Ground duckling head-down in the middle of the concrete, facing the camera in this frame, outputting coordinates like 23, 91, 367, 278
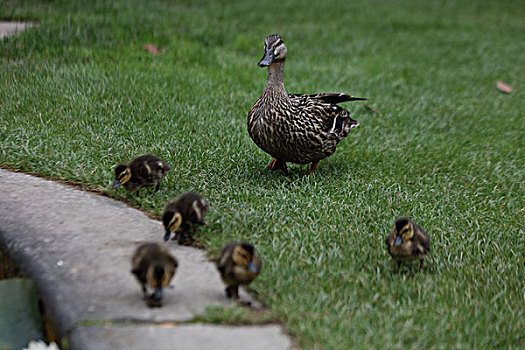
131, 243, 179, 307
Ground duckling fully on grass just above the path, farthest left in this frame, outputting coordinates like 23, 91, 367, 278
113, 154, 171, 194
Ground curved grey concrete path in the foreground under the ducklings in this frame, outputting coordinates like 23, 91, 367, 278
0, 169, 292, 350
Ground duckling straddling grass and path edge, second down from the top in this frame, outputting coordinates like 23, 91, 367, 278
162, 192, 210, 245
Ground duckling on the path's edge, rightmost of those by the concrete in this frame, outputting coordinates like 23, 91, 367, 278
215, 242, 262, 299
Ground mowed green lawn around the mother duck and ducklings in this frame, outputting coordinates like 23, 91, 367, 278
0, 0, 525, 349
